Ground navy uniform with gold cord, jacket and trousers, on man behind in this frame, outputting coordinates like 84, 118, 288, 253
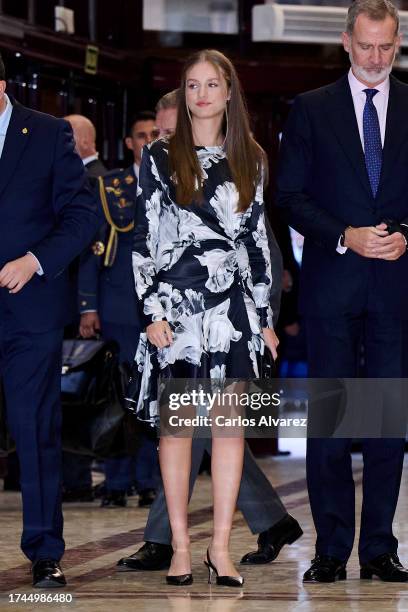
78, 166, 158, 506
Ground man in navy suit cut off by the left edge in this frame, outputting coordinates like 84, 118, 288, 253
0, 59, 98, 587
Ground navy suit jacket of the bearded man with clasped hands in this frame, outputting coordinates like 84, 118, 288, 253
278, 76, 408, 318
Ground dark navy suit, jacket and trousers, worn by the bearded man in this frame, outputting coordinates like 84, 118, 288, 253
278, 77, 408, 563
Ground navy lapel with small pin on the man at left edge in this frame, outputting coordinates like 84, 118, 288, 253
0, 99, 31, 196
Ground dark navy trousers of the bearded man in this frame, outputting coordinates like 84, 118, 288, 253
306, 313, 408, 563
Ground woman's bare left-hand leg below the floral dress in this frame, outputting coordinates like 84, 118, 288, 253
159, 436, 191, 576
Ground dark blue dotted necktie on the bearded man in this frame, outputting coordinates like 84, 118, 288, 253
363, 89, 382, 197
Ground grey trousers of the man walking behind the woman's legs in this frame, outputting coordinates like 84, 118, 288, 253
143, 438, 287, 544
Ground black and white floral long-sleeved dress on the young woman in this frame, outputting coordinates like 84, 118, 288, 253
132, 139, 273, 422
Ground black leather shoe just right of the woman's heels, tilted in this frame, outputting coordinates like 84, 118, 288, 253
241, 514, 303, 565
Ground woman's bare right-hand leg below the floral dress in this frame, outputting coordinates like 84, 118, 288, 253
209, 438, 245, 576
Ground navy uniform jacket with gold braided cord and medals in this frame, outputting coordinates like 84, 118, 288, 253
78, 165, 141, 327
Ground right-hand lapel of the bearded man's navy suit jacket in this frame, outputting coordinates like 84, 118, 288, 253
378, 76, 408, 193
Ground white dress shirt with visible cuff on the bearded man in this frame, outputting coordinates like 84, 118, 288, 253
336, 68, 390, 255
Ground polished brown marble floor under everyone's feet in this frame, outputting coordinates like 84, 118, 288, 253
0, 452, 408, 612
